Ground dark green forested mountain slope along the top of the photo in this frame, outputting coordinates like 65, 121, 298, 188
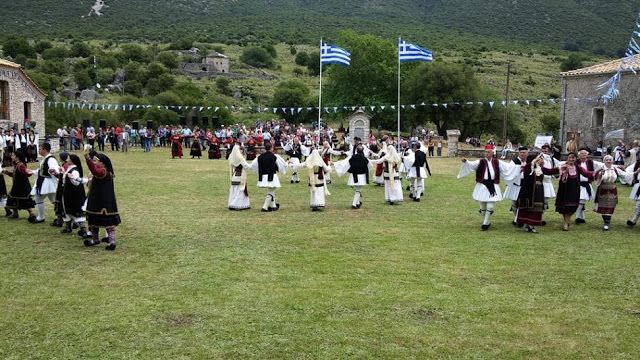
0, 0, 640, 56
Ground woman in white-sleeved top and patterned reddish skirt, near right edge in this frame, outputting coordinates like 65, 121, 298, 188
593, 155, 626, 231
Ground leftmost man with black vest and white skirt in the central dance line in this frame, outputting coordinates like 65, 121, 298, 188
251, 142, 287, 212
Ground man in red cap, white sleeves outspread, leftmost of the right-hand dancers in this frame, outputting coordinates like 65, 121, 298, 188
458, 145, 521, 230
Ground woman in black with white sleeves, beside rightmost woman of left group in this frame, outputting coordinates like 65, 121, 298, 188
60, 154, 88, 237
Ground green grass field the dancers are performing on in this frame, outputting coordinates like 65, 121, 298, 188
0, 148, 640, 359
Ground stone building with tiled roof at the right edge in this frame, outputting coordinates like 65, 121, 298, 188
560, 55, 640, 149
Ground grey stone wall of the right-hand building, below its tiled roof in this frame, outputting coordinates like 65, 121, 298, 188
561, 73, 640, 149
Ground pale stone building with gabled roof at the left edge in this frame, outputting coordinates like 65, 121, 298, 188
0, 59, 46, 138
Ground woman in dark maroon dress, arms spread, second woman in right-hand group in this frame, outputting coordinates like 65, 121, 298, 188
542, 152, 594, 231
